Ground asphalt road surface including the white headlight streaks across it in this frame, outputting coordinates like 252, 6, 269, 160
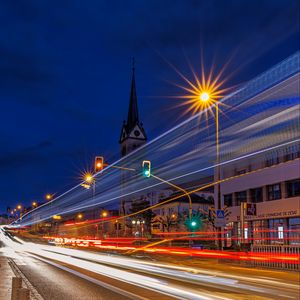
0, 229, 299, 300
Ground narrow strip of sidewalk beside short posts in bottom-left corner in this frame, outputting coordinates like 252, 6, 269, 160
0, 252, 14, 300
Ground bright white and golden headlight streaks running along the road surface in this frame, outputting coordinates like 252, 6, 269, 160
0, 230, 298, 299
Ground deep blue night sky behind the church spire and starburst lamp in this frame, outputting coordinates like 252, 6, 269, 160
0, 0, 300, 213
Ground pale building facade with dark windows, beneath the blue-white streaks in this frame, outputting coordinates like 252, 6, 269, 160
221, 144, 300, 246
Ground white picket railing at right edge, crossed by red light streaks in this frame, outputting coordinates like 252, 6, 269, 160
251, 245, 300, 270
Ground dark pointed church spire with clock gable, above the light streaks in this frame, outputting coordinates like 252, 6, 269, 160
119, 60, 147, 157
